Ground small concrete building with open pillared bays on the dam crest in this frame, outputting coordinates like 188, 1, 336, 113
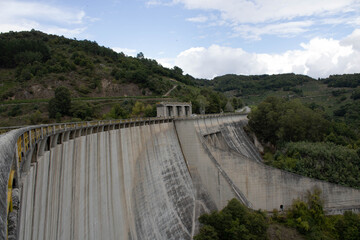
156, 102, 192, 117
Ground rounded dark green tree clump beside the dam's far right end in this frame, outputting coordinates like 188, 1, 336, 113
249, 97, 330, 145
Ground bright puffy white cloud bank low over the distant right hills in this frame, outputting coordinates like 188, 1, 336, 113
174, 29, 360, 79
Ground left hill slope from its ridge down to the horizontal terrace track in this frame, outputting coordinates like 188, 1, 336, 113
0, 31, 195, 100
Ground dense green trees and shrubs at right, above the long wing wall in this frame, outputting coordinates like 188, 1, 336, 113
249, 97, 360, 188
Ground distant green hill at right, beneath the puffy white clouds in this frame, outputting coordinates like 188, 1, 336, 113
205, 74, 360, 126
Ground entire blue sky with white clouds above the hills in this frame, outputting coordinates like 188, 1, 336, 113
0, 0, 360, 79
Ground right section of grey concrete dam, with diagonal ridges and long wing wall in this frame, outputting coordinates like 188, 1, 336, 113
175, 116, 360, 214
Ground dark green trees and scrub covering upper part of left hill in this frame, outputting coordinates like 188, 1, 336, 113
0, 30, 193, 99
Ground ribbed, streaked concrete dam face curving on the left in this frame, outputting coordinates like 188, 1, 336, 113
19, 123, 195, 239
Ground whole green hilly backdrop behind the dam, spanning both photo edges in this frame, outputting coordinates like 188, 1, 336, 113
0, 30, 360, 129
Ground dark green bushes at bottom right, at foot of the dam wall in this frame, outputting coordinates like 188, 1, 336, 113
194, 189, 360, 240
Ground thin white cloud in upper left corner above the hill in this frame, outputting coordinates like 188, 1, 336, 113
0, 0, 89, 37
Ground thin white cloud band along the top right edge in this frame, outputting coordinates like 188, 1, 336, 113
173, 0, 359, 23
